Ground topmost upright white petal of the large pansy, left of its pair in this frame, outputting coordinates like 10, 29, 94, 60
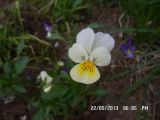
76, 28, 94, 54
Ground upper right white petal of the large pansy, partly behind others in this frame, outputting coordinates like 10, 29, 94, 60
92, 32, 115, 52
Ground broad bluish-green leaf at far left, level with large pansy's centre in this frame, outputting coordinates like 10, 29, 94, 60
15, 56, 29, 74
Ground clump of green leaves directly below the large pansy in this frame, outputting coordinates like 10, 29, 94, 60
31, 66, 106, 120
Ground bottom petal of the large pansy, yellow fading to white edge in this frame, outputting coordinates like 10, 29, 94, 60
70, 63, 100, 84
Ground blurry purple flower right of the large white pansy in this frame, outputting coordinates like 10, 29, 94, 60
120, 38, 135, 59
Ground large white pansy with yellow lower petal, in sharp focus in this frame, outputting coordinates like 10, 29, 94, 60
68, 28, 115, 84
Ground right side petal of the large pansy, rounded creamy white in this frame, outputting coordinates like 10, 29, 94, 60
90, 47, 111, 66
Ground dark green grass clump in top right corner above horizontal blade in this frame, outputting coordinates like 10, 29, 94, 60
120, 0, 160, 27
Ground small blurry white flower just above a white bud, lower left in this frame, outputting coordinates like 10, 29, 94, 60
37, 71, 53, 83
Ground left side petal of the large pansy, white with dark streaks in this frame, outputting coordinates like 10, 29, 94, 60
68, 43, 88, 63
